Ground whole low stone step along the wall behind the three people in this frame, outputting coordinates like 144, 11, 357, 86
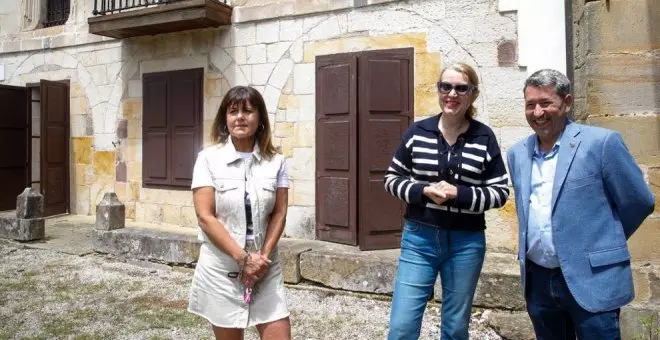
94, 226, 524, 310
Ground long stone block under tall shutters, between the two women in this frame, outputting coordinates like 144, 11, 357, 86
300, 241, 399, 294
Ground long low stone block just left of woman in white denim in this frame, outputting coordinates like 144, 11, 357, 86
94, 228, 201, 265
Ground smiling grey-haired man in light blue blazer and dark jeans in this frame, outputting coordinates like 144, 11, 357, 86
508, 69, 655, 340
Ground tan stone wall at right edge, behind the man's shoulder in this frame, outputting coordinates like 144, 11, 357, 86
573, 0, 660, 261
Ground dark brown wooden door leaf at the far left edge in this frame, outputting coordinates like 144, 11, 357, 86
0, 85, 30, 211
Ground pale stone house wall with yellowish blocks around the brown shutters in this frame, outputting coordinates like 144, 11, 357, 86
0, 0, 531, 252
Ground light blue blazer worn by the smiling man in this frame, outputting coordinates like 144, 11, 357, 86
508, 121, 655, 312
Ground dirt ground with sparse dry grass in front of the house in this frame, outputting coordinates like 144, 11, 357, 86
0, 240, 500, 340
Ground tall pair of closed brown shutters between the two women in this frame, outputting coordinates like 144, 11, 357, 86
316, 48, 414, 250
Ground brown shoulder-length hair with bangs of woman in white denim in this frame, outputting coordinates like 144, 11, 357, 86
211, 86, 277, 159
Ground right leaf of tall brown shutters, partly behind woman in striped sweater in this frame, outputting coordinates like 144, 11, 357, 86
358, 48, 414, 250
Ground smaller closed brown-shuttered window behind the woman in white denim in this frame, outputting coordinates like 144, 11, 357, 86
142, 69, 204, 189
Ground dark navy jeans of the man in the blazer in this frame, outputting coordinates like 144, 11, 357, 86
525, 261, 621, 340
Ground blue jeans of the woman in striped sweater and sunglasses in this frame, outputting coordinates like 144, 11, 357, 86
387, 221, 486, 340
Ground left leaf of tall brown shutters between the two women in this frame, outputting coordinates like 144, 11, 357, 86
316, 54, 358, 245
